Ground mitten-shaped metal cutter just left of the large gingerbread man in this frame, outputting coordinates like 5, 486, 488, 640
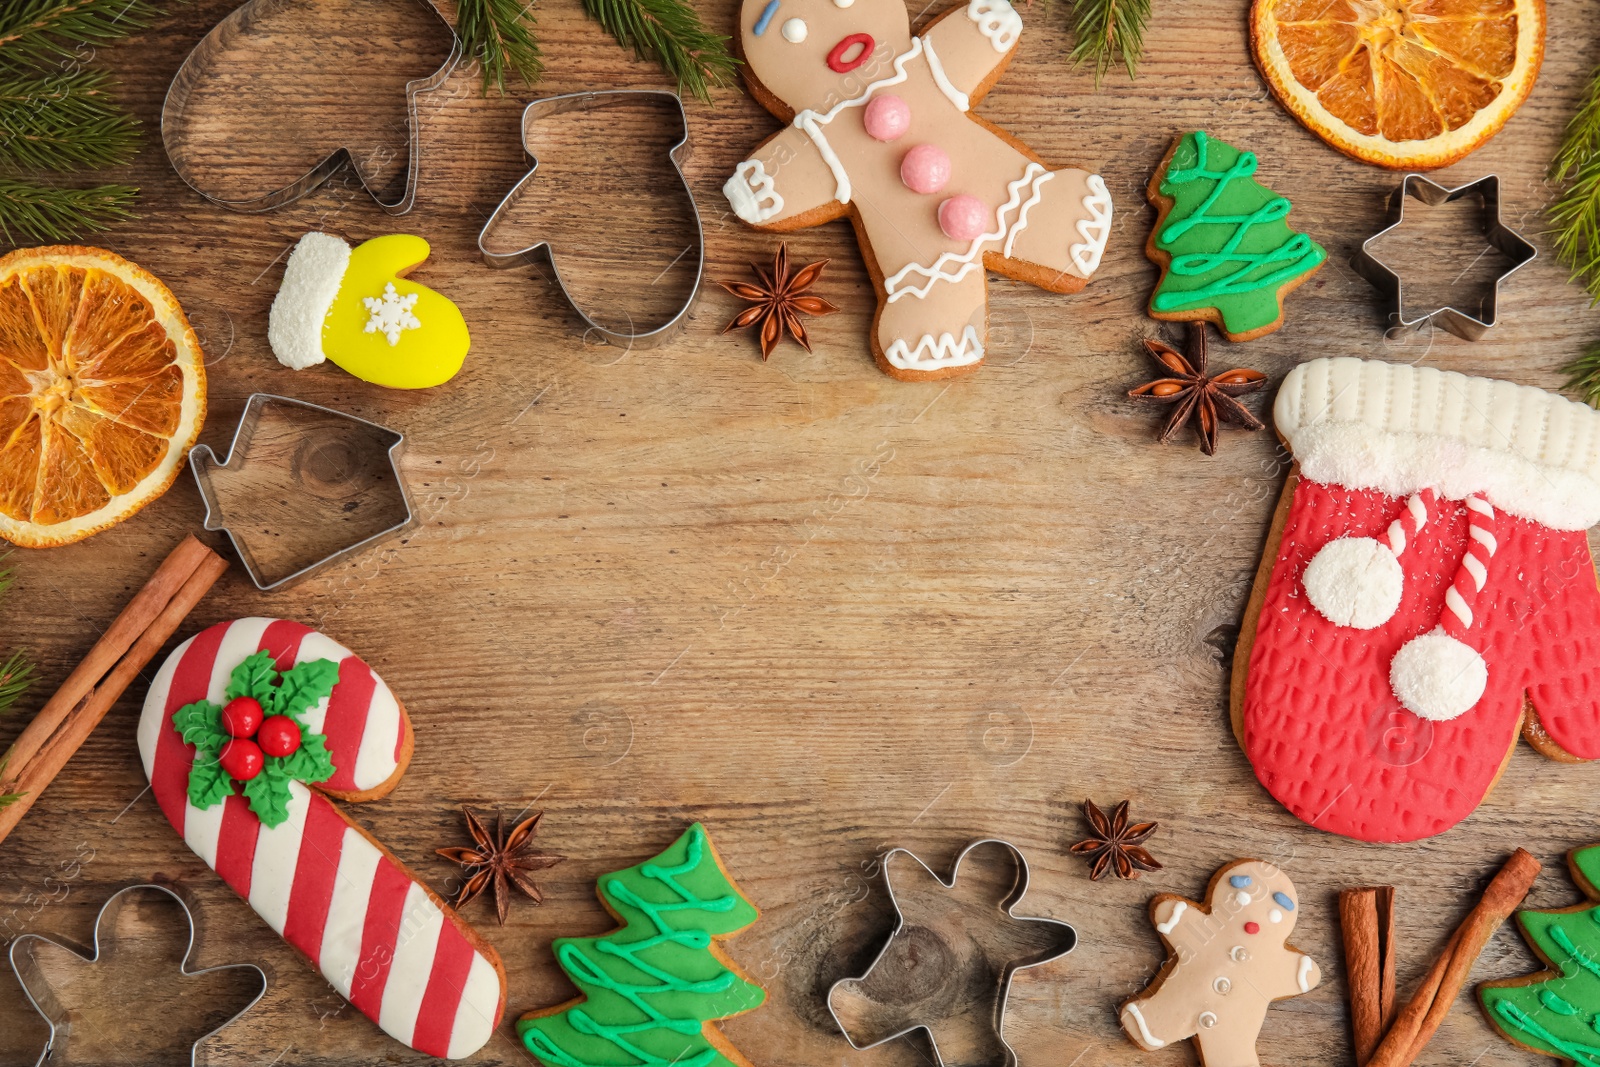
478, 90, 706, 349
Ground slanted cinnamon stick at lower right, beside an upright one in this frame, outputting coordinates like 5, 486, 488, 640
1368, 848, 1539, 1067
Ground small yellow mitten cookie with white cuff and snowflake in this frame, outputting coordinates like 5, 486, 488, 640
267, 232, 472, 389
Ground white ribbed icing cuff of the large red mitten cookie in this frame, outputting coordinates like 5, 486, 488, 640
1272, 357, 1600, 530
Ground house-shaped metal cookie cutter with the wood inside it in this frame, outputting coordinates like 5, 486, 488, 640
189, 394, 414, 592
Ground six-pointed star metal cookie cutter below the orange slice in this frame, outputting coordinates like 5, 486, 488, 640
1350, 174, 1539, 341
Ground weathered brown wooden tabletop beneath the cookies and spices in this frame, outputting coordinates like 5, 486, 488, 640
0, 0, 1600, 1067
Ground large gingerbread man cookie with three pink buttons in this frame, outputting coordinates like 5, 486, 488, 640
723, 0, 1110, 381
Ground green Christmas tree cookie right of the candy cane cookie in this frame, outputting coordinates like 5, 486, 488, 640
517, 822, 766, 1067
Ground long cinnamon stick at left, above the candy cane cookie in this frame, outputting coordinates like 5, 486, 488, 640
0, 536, 227, 841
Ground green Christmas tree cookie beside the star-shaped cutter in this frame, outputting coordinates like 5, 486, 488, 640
1146, 130, 1328, 341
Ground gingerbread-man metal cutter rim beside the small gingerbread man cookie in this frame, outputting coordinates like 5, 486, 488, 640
827, 837, 1078, 1067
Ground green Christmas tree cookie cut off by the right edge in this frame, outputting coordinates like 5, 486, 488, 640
1478, 845, 1600, 1067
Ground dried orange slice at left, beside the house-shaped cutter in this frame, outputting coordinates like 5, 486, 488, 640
0, 246, 205, 549
